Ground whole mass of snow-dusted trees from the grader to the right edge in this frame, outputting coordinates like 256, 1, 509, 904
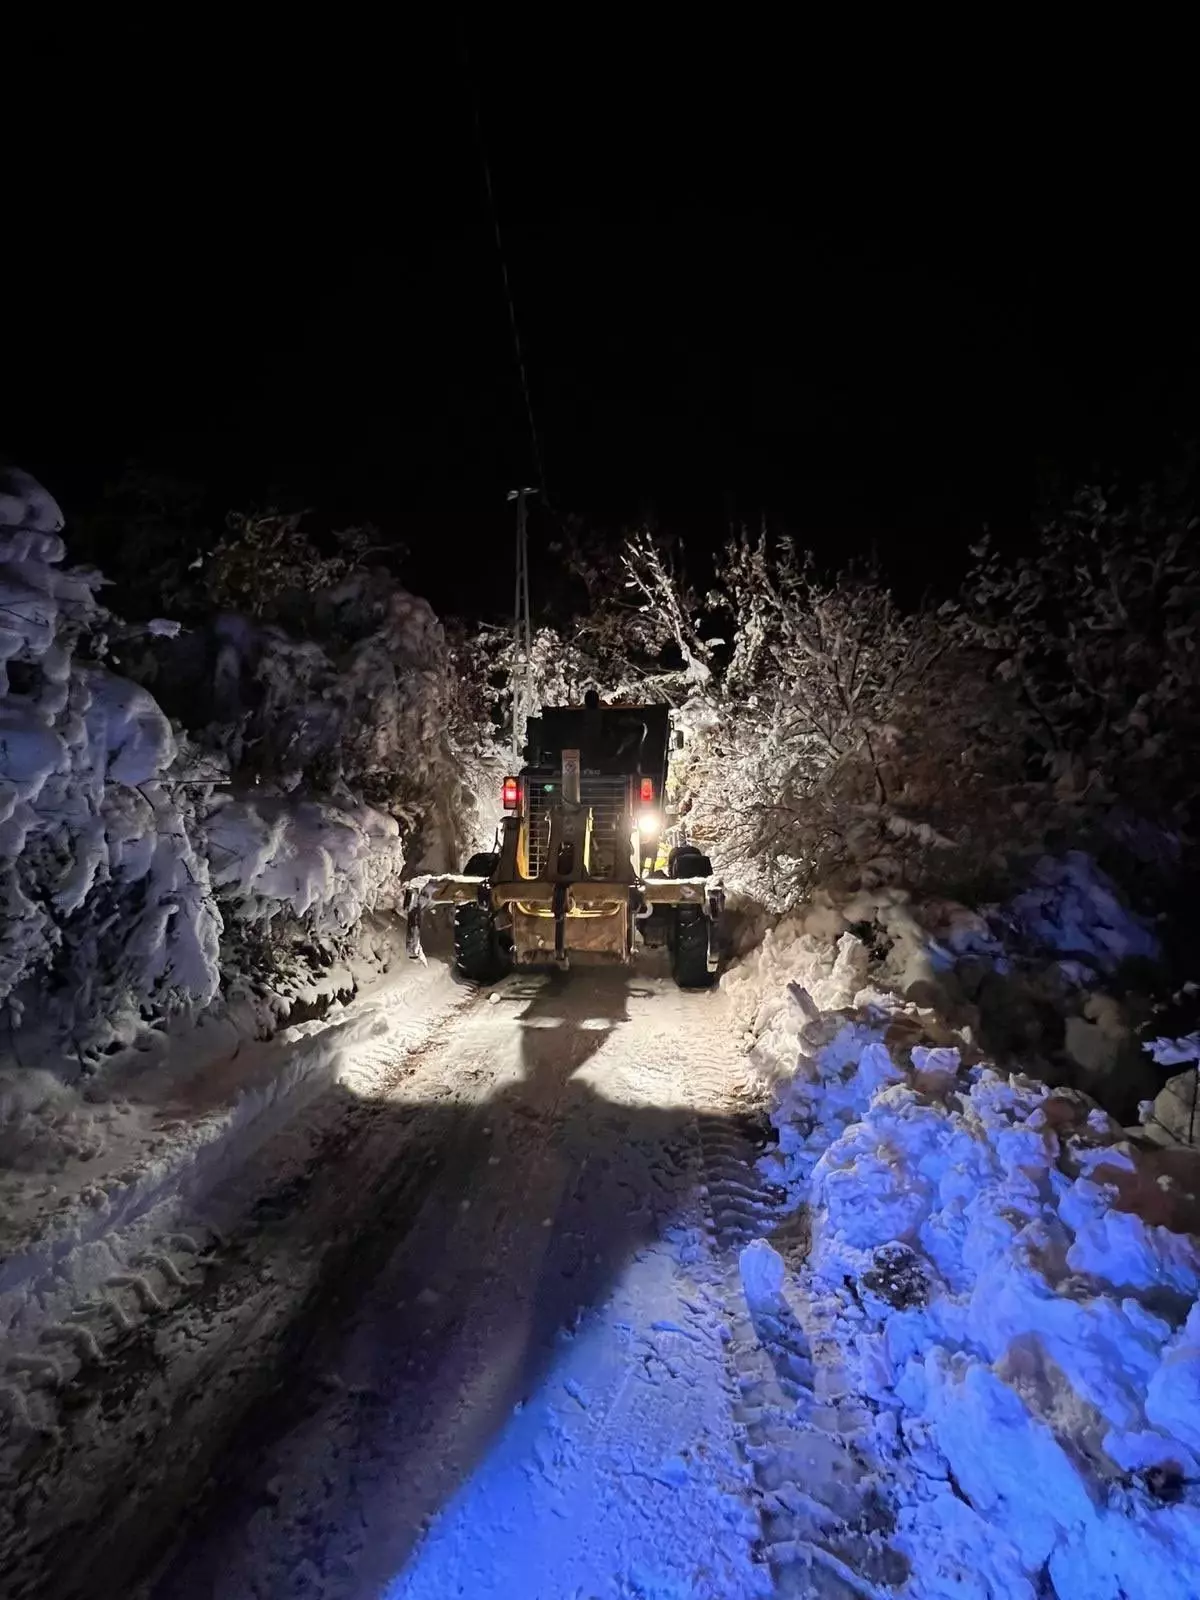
626, 491, 1200, 907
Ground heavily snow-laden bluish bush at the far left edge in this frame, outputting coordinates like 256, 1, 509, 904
0, 472, 221, 1048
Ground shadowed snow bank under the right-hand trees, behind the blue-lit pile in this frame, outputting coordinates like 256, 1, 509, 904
725, 853, 1181, 1130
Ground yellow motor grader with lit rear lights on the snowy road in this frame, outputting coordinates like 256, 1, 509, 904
405, 694, 725, 989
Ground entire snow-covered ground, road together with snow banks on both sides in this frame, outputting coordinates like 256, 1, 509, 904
0, 902, 1200, 1600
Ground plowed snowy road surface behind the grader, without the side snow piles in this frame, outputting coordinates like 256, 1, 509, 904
5, 971, 813, 1600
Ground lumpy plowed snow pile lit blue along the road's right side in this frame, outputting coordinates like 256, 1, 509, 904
726, 896, 1200, 1600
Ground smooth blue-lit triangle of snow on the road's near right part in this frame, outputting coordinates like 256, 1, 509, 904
395, 1229, 771, 1600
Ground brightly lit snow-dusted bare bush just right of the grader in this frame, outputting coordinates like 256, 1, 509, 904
582, 534, 1029, 910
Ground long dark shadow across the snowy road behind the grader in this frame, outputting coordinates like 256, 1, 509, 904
37, 973, 752, 1600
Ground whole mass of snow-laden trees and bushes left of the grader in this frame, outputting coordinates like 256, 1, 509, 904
0, 474, 498, 1062
